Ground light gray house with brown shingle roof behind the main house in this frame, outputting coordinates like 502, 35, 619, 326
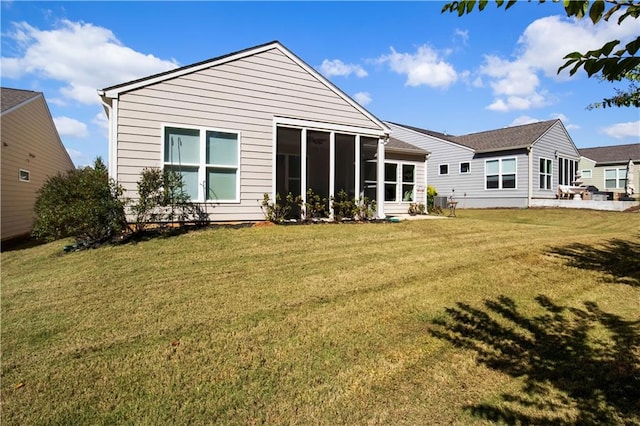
386, 120, 580, 208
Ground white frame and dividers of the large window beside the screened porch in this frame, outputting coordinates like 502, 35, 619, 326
160, 123, 242, 204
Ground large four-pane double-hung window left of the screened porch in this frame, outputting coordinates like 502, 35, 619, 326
164, 127, 240, 202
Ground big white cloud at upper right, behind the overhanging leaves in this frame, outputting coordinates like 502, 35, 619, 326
479, 16, 637, 111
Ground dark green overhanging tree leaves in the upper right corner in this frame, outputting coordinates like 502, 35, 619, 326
442, 0, 640, 86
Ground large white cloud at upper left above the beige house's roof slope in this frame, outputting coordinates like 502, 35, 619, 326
1, 20, 177, 104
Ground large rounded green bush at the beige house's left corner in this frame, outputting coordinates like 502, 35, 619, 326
32, 157, 126, 246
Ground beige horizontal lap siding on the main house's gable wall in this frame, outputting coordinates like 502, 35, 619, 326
117, 49, 379, 220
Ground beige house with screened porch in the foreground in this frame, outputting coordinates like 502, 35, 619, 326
98, 41, 427, 221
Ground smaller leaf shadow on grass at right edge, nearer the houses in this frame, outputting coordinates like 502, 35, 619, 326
551, 239, 640, 286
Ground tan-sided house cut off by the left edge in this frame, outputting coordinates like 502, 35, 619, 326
0, 87, 74, 243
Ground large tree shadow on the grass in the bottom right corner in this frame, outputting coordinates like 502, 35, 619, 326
431, 296, 640, 425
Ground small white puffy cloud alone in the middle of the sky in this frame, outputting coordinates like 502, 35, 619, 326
377, 45, 458, 88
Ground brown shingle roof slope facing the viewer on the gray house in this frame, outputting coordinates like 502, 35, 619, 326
456, 120, 559, 152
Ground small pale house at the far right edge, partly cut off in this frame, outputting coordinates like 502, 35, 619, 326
578, 143, 640, 198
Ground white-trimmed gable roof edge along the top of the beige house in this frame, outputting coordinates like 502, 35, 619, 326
98, 40, 390, 133
